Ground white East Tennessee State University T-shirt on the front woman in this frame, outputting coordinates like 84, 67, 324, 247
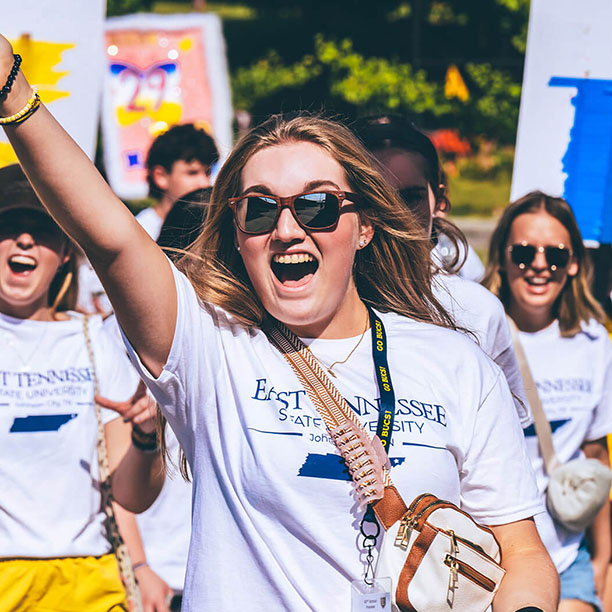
123, 270, 542, 612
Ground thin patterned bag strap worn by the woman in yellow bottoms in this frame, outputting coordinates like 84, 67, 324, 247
83, 316, 143, 612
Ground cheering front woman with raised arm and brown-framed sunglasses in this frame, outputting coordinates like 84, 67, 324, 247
0, 39, 557, 612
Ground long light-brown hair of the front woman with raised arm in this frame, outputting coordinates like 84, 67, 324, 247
179, 114, 455, 328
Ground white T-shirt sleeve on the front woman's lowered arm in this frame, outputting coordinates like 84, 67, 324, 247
460, 369, 544, 525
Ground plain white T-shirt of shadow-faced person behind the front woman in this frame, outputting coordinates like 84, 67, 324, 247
432, 272, 533, 427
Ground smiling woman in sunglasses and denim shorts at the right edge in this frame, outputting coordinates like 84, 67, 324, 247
484, 192, 612, 612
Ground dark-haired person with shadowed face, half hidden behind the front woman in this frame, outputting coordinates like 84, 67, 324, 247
354, 115, 531, 427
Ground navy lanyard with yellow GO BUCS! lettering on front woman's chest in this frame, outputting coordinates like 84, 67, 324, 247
368, 306, 395, 455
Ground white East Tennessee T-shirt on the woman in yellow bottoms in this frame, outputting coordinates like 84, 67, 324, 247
0, 313, 138, 558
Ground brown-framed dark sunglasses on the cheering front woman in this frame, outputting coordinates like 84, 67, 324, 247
229, 191, 360, 235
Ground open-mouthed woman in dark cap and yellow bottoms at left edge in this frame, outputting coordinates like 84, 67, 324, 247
0, 165, 164, 612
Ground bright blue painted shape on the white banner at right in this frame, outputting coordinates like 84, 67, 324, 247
548, 76, 612, 244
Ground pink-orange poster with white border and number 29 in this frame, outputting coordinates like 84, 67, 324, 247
102, 13, 233, 198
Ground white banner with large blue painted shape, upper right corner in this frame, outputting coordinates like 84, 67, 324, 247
511, 0, 612, 243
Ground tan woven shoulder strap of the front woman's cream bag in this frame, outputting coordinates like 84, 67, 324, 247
264, 322, 408, 529
